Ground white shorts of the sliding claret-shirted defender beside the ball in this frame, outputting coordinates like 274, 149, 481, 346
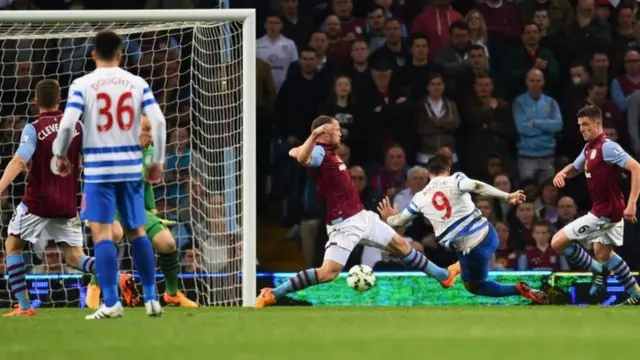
324, 210, 396, 265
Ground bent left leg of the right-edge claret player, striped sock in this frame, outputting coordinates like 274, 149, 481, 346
551, 228, 609, 296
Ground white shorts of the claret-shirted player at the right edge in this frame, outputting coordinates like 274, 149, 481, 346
564, 213, 624, 246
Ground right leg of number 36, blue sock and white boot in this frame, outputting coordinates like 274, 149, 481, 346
127, 226, 163, 317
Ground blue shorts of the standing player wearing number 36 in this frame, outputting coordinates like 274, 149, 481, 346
80, 180, 146, 231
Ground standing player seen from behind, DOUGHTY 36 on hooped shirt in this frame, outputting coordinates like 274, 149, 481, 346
53, 31, 166, 320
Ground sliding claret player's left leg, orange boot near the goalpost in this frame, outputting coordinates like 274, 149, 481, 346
255, 258, 344, 308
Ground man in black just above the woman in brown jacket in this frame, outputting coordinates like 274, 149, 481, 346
394, 34, 442, 100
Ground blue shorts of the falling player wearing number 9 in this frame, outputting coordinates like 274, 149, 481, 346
458, 224, 499, 284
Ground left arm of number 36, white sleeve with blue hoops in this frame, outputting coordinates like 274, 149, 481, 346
53, 83, 84, 157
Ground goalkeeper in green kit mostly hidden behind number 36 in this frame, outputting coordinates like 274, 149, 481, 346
86, 116, 198, 309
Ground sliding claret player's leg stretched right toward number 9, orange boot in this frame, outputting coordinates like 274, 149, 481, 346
385, 234, 460, 289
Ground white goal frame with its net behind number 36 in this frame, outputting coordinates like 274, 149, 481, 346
0, 9, 257, 307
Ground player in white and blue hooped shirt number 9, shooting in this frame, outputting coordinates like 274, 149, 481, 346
380, 155, 546, 303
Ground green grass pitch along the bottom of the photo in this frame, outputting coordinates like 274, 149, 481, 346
0, 307, 640, 360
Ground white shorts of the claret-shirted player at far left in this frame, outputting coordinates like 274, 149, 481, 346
9, 204, 84, 248
